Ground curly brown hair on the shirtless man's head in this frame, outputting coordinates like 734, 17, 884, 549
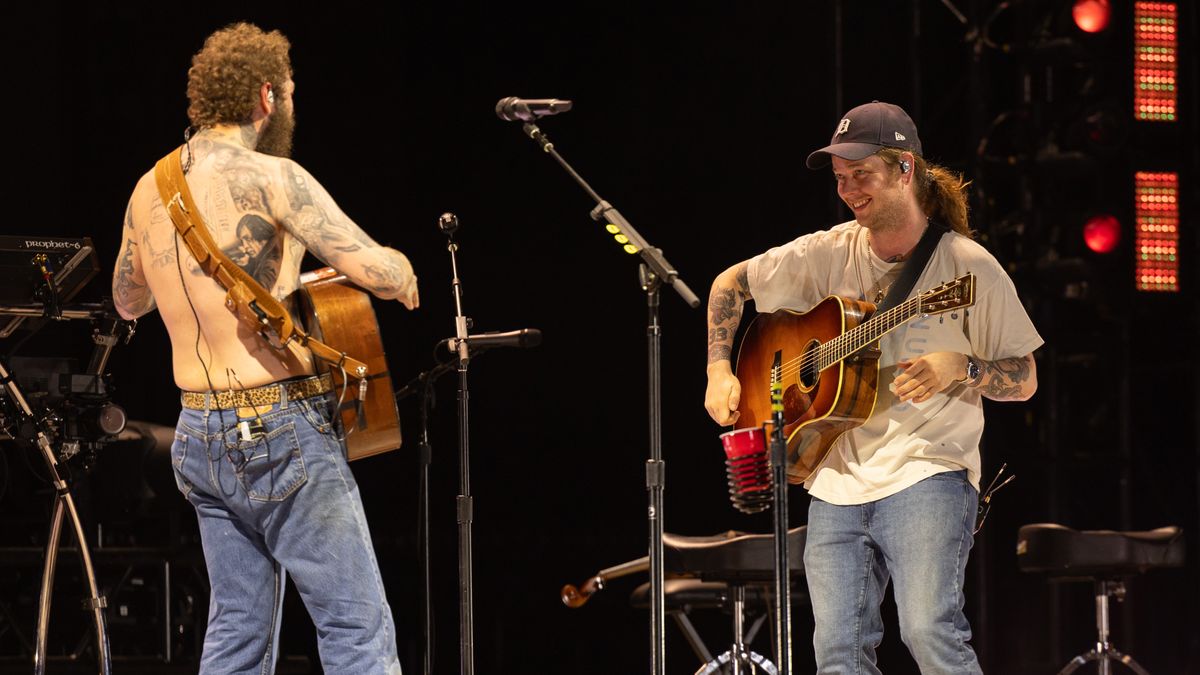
187, 23, 292, 129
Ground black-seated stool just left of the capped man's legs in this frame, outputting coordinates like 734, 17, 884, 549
630, 526, 808, 675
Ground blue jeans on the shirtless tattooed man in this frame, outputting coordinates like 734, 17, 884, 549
170, 389, 400, 675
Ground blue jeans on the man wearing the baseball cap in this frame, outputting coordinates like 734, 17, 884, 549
804, 471, 982, 675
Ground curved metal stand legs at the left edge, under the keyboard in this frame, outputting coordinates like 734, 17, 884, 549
0, 362, 112, 675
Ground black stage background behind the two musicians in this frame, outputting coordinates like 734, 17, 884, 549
0, 0, 1200, 674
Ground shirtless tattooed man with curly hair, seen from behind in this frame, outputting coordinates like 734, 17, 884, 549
113, 23, 419, 675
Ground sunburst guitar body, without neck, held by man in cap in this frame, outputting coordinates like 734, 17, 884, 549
734, 297, 880, 483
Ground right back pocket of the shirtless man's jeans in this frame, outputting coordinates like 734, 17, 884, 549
234, 422, 308, 502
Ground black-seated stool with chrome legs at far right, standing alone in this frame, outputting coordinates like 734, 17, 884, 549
1016, 522, 1184, 675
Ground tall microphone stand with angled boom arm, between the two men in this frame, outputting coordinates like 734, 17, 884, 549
521, 121, 700, 675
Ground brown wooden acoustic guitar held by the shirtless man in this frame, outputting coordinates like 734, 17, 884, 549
295, 267, 401, 461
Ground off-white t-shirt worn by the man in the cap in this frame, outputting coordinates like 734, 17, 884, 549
748, 221, 1043, 504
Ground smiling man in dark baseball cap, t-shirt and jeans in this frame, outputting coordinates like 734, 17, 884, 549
704, 101, 1043, 674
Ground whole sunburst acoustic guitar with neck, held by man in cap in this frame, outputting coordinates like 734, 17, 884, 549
734, 274, 974, 483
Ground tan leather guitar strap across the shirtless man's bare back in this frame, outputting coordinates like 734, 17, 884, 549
154, 145, 367, 380
